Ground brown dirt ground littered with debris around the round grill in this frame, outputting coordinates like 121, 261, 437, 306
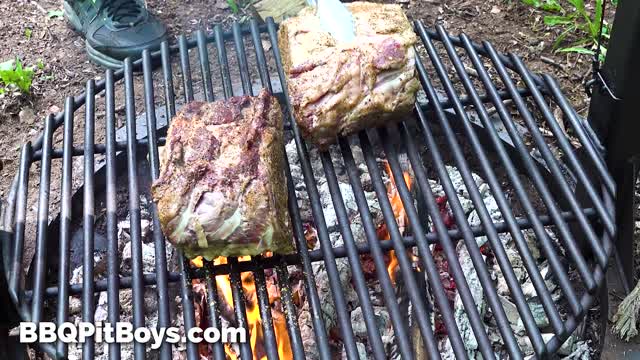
0, 0, 624, 356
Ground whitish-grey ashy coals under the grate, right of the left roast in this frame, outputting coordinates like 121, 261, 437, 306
286, 135, 580, 359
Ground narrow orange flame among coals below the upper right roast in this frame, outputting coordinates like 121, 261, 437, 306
378, 162, 411, 283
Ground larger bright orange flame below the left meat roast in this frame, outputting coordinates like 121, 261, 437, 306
191, 253, 293, 360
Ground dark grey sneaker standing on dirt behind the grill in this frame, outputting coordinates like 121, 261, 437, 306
64, 0, 167, 69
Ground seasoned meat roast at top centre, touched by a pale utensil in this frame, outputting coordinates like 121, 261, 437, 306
279, 2, 419, 148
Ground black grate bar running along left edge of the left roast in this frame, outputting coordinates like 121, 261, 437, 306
142, 50, 172, 360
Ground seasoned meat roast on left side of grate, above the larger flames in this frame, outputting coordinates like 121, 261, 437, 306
152, 91, 293, 259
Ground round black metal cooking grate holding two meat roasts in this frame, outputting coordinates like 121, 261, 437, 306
4, 19, 615, 359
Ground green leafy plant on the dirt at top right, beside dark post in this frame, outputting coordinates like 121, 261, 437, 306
522, 0, 617, 60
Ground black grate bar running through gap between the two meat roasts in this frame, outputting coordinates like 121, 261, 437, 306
266, 18, 342, 360
